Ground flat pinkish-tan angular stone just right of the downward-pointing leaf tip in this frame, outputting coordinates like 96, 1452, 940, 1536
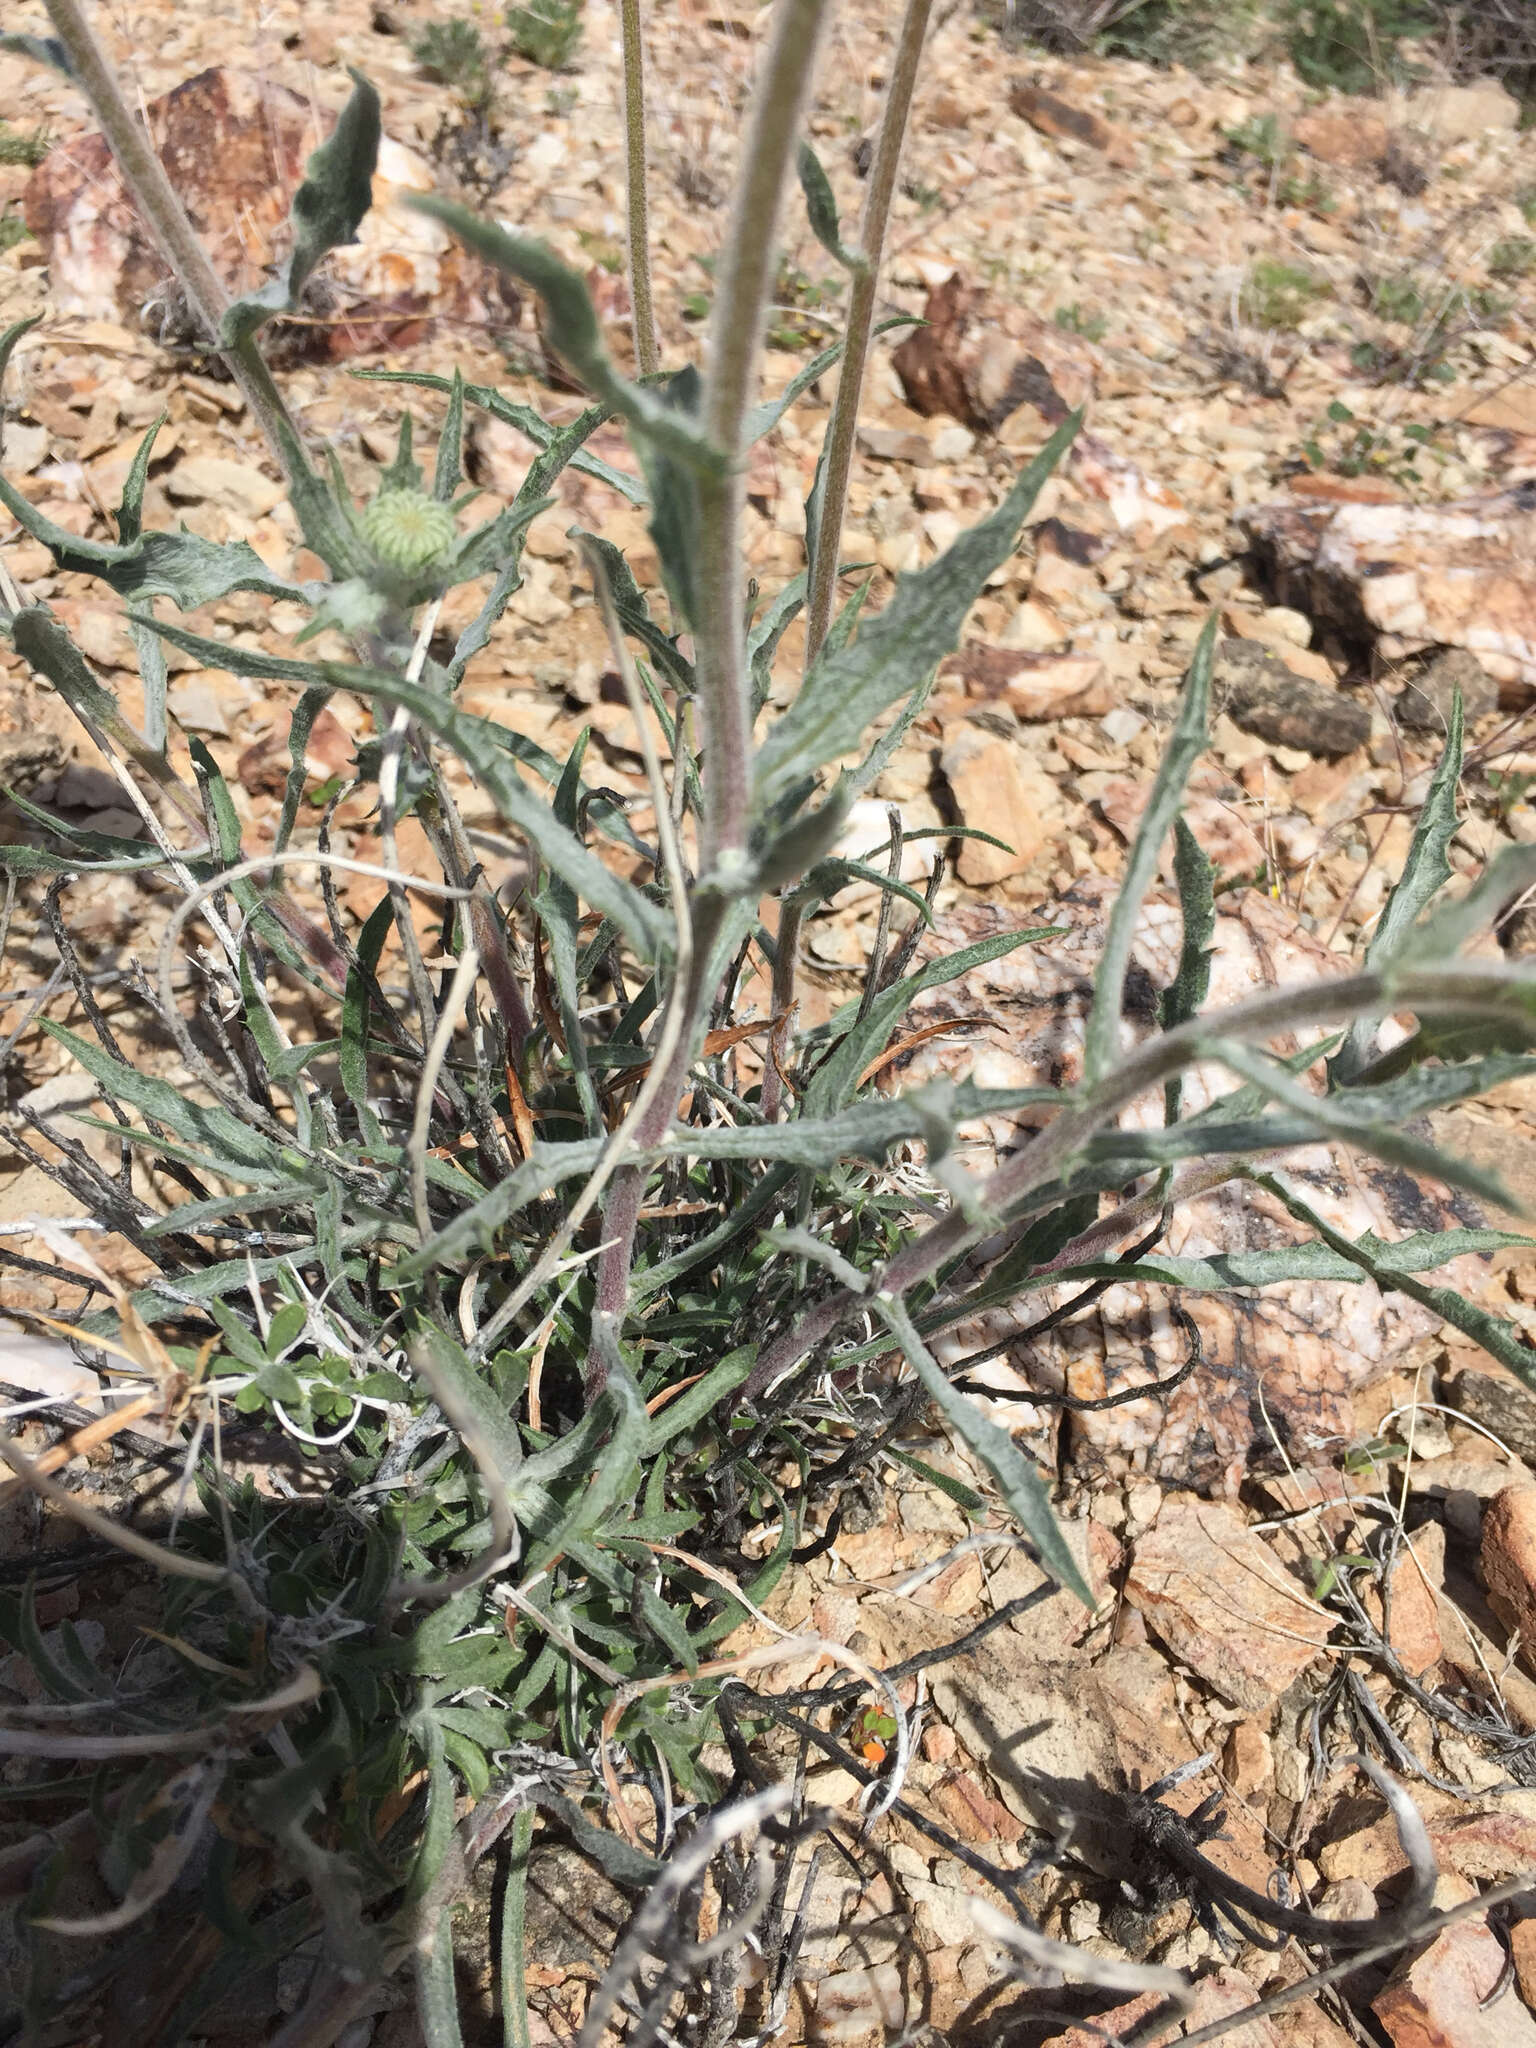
1124, 1503, 1329, 1714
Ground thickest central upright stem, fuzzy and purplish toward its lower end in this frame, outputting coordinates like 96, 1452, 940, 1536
692, 0, 825, 874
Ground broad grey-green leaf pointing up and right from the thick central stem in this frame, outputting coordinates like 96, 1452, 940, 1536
758, 414, 1081, 805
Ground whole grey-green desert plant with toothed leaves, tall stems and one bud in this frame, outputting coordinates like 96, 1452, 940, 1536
0, 0, 1536, 2048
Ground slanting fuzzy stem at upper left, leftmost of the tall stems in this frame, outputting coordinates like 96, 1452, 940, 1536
45, 0, 313, 477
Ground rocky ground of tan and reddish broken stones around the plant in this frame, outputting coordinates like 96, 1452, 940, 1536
0, 0, 1536, 2048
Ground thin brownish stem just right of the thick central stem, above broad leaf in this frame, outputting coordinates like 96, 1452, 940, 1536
805, 0, 932, 670
